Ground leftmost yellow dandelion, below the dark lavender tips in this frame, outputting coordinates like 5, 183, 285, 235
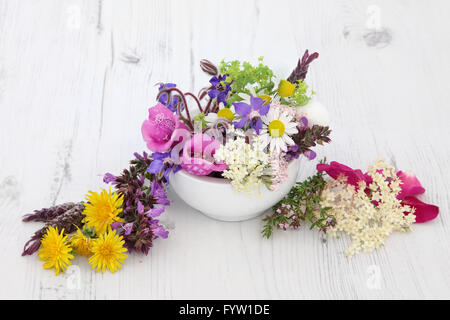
38, 226, 73, 275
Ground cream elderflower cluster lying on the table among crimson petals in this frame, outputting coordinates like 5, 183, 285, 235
322, 160, 416, 256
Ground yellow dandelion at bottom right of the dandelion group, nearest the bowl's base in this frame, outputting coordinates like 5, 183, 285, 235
89, 228, 128, 273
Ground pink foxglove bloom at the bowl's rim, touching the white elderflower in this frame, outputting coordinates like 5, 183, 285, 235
181, 133, 227, 176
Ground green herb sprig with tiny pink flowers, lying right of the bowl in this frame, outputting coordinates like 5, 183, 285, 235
262, 172, 336, 238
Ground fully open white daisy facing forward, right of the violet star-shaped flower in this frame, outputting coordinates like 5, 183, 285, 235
261, 108, 298, 153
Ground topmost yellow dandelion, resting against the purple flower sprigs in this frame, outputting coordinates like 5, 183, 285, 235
83, 188, 123, 234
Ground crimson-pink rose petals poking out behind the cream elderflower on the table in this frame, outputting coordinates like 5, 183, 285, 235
317, 161, 439, 223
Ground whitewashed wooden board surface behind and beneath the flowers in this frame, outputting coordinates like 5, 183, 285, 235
0, 0, 450, 299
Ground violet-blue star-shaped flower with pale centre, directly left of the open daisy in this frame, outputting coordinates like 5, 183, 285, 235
233, 95, 270, 134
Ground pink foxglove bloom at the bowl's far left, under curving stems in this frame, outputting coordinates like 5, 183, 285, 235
141, 103, 189, 152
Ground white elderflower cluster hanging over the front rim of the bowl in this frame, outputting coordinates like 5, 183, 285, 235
214, 126, 270, 194
